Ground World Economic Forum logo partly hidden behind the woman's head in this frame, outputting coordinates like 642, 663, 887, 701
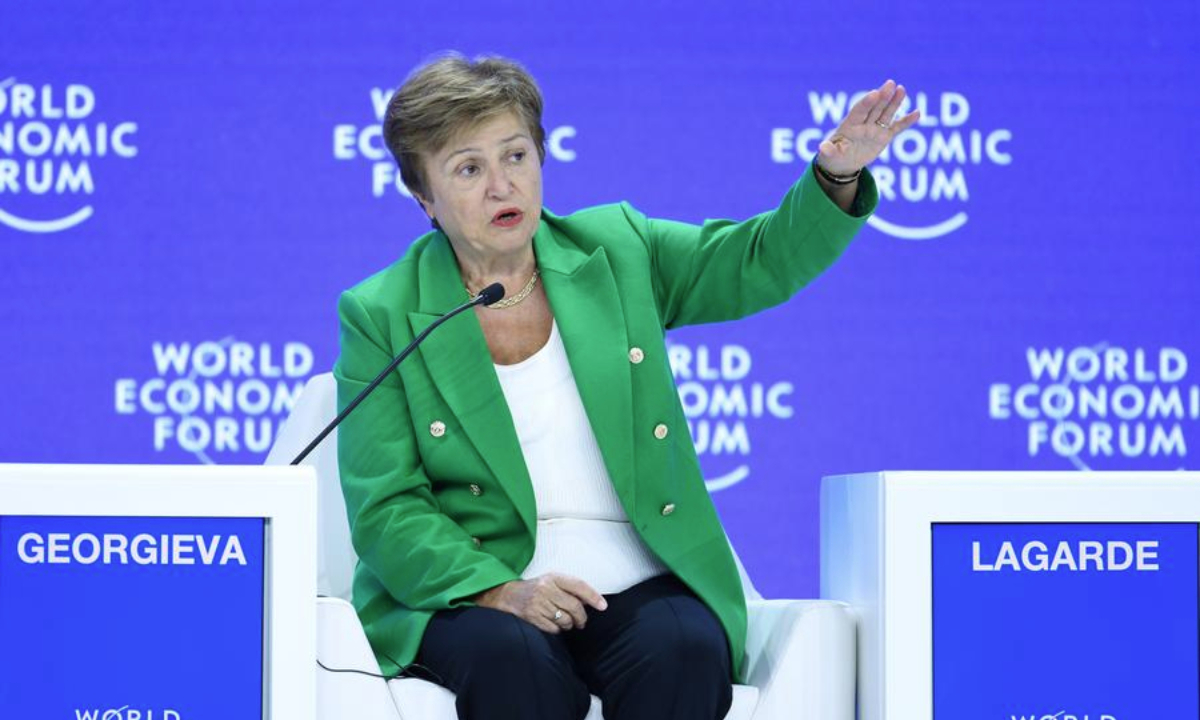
334, 88, 576, 198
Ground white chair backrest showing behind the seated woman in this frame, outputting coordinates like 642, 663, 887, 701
266, 373, 762, 600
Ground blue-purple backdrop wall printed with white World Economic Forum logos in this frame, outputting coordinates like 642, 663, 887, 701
0, 0, 1200, 596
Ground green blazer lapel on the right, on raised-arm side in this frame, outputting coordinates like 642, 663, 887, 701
534, 221, 635, 517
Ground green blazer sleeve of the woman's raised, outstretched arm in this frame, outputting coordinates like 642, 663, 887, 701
624, 163, 878, 329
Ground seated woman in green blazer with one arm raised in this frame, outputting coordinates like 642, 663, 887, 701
335, 51, 917, 720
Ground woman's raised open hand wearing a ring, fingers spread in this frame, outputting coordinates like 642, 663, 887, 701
817, 80, 920, 175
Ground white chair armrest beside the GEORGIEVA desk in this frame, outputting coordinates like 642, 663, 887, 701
317, 598, 400, 720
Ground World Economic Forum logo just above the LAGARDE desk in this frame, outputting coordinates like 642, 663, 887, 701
988, 342, 1200, 470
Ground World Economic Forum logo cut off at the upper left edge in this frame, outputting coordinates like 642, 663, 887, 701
0, 77, 138, 233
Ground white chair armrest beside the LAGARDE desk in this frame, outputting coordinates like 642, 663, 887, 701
745, 600, 856, 720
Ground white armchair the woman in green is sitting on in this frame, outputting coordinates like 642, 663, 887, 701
266, 373, 856, 720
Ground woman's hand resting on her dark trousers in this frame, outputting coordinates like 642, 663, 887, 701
475, 572, 608, 635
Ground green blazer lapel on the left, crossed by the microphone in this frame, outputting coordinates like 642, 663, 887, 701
408, 235, 536, 536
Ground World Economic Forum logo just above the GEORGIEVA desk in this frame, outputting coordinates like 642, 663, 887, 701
113, 337, 313, 464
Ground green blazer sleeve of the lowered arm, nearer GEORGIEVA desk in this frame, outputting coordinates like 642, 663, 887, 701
334, 290, 520, 610
